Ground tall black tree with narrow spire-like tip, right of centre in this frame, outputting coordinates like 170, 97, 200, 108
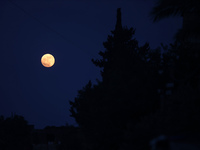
70, 9, 160, 149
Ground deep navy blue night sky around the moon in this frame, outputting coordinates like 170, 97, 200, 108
0, 0, 182, 128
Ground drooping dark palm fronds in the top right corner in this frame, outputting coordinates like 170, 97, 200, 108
150, 0, 200, 43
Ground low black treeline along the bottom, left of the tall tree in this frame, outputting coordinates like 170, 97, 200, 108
0, 115, 84, 150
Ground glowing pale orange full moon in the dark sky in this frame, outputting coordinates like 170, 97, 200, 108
41, 54, 55, 68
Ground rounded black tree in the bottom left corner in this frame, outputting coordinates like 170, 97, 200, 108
0, 115, 32, 150
